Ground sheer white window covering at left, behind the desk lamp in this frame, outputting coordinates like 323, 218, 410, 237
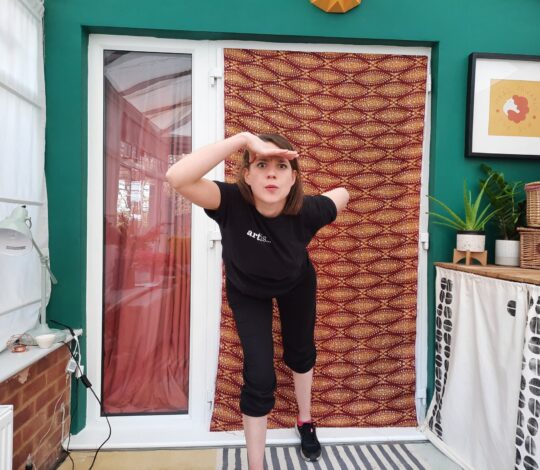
0, 0, 48, 351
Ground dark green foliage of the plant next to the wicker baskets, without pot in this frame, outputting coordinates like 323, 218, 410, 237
480, 163, 526, 240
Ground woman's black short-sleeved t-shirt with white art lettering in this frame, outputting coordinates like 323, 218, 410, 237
205, 181, 337, 298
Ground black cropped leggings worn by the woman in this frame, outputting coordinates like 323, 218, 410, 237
226, 263, 317, 417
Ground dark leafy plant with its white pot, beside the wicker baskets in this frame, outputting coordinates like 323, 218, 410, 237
480, 163, 526, 266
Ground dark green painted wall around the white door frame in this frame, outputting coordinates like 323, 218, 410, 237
45, 0, 540, 432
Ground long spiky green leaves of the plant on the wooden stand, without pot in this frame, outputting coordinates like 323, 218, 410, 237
428, 176, 498, 232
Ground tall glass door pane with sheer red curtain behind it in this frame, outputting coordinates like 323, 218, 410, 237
102, 50, 192, 415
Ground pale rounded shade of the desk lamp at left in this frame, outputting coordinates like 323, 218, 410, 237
0, 206, 32, 256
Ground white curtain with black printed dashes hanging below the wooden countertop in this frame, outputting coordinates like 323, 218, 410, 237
423, 268, 528, 470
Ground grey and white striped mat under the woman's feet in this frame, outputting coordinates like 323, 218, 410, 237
216, 443, 427, 470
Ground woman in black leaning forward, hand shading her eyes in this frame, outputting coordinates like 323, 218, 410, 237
167, 132, 349, 470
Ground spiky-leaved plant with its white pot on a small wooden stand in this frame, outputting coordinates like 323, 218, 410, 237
428, 176, 498, 252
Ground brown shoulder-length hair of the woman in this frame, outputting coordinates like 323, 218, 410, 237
236, 134, 304, 215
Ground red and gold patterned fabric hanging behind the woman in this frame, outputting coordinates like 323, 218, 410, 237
211, 49, 427, 431
